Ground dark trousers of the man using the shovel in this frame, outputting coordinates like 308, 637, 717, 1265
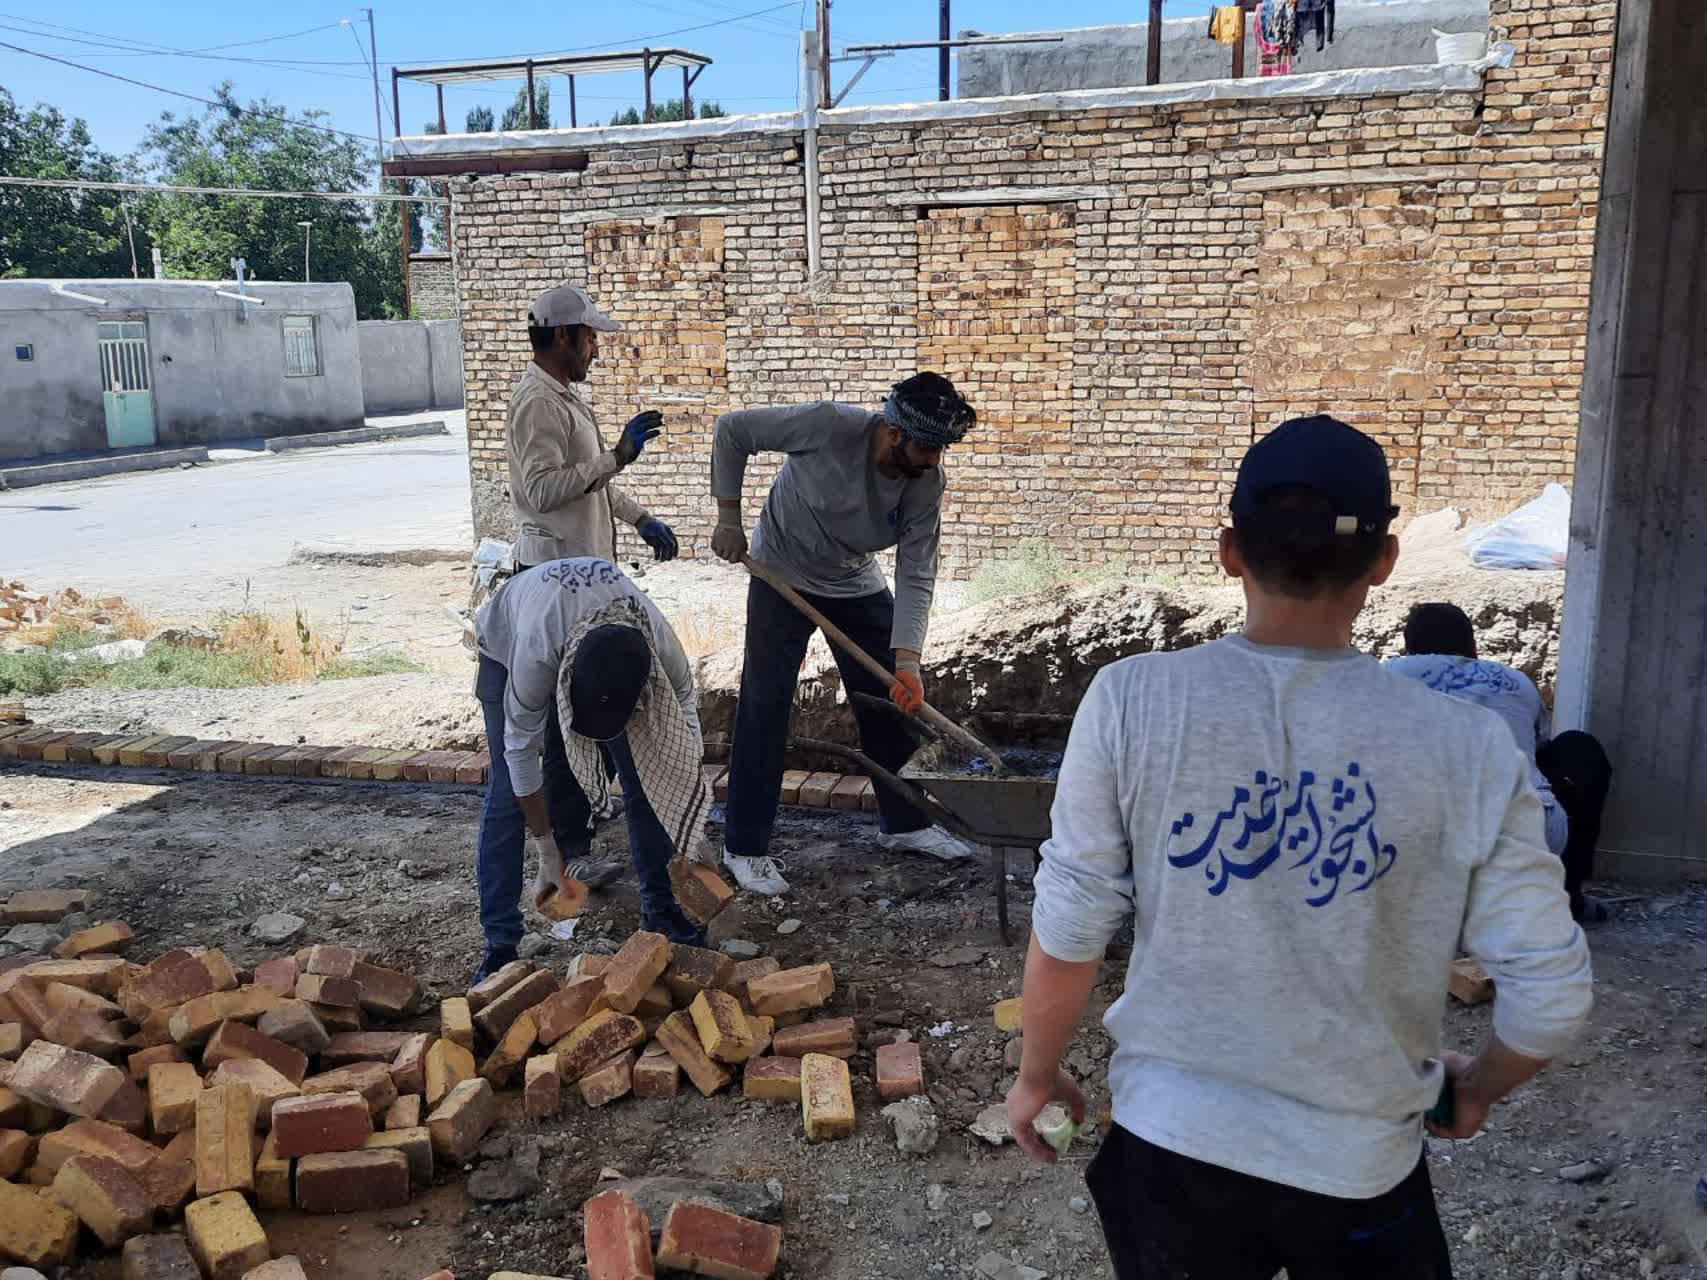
724, 579, 930, 857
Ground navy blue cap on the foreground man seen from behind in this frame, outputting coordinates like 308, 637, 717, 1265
1232, 413, 1398, 534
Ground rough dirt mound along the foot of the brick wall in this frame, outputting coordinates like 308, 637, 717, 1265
698, 565, 1564, 742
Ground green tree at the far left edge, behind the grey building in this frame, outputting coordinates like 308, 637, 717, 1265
0, 87, 150, 278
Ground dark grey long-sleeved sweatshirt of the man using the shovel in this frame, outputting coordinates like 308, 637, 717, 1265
712, 401, 947, 650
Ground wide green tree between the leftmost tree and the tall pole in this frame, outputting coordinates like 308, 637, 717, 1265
140, 84, 403, 319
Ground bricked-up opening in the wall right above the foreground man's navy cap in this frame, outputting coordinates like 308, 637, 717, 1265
1250, 186, 1441, 510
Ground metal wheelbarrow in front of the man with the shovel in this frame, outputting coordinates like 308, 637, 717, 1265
789, 727, 1055, 944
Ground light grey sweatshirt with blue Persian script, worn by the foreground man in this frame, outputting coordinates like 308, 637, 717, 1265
1033, 637, 1593, 1200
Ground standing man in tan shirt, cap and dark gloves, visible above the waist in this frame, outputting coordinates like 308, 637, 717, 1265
505, 285, 676, 570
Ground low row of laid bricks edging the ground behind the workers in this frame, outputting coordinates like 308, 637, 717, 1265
0, 724, 877, 812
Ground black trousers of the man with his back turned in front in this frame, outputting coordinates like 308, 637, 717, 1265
1086, 1125, 1453, 1280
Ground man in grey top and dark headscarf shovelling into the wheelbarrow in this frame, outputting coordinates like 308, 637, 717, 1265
712, 374, 976, 894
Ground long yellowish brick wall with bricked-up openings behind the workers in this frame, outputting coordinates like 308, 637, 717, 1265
452, 0, 1615, 573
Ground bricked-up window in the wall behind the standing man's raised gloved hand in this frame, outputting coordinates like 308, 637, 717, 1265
587, 217, 729, 558
